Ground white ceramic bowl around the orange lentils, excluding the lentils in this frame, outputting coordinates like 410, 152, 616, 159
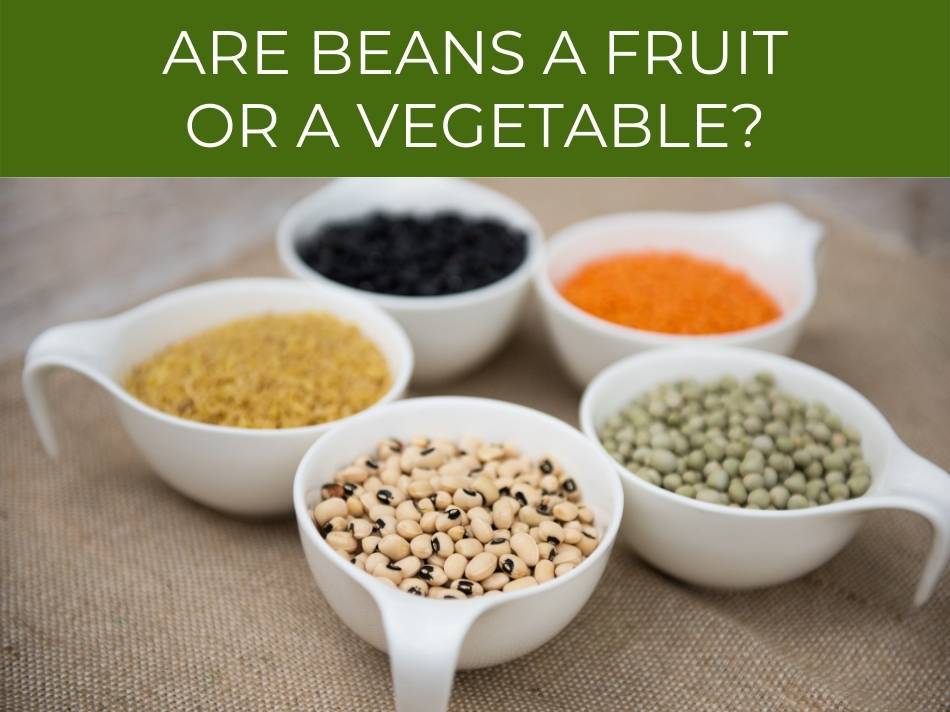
535, 204, 823, 387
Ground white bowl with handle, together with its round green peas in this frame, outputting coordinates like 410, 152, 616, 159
580, 346, 950, 605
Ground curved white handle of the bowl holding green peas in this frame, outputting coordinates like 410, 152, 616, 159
880, 445, 950, 606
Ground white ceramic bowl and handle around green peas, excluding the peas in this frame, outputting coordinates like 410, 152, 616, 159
580, 346, 950, 605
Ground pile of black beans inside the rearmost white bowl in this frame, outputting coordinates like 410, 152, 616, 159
296, 213, 527, 296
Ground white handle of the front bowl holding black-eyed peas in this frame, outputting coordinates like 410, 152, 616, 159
376, 590, 485, 712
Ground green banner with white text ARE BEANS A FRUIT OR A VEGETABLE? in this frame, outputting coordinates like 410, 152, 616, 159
0, 0, 950, 176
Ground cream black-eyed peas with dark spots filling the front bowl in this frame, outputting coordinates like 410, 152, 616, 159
312, 437, 600, 598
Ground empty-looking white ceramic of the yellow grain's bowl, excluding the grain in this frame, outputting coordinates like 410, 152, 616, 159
23, 279, 412, 516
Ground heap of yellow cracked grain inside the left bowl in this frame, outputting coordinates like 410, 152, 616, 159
125, 312, 391, 428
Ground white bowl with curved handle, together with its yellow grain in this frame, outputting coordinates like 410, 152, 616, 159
23, 279, 412, 516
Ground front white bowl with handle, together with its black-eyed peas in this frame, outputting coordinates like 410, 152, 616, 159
294, 397, 623, 711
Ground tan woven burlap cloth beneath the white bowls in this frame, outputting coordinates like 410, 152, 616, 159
0, 181, 950, 712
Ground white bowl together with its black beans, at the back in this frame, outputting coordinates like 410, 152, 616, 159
277, 178, 542, 384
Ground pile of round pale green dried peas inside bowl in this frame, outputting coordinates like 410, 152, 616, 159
599, 373, 871, 509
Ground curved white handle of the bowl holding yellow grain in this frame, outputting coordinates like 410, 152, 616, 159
23, 319, 114, 458
